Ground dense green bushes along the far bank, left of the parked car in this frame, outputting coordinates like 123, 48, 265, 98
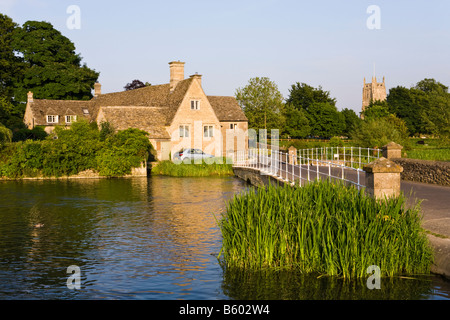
0, 121, 152, 179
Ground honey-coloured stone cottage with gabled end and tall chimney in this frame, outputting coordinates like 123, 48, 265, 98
24, 61, 248, 160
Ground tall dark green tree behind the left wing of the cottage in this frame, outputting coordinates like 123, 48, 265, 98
11, 21, 99, 101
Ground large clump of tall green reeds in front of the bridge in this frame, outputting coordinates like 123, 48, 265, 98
218, 181, 433, 278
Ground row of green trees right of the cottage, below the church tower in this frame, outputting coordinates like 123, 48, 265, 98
235, 77, 450, 147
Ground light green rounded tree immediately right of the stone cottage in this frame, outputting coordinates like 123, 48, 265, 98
236, 77, 284, 130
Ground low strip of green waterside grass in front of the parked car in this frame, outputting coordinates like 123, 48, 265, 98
152, 160, 233, 177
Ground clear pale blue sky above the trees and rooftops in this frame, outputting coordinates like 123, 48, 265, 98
0, 0, 450, 113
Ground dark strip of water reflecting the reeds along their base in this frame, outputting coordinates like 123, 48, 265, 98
222, 270, 450, 300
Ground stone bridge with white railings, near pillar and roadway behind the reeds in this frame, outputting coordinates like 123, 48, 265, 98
232, 144, 450, 278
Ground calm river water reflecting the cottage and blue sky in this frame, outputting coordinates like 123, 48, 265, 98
0, 177, 450, 300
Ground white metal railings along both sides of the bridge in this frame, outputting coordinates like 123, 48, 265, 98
233, 147, 381, 189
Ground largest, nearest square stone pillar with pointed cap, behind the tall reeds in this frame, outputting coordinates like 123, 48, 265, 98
363, 157, 403, 199
